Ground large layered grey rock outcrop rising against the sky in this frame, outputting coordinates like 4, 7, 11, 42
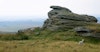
43, 6, 97, 31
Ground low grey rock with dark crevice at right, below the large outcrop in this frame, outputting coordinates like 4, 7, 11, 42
74, 27, 100, 38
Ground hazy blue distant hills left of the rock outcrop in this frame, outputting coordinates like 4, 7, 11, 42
0, 20, 43, 32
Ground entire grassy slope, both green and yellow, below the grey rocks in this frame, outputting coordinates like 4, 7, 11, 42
0, 23, 100, 52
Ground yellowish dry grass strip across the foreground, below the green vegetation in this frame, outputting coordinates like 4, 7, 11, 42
0, 39, 100, 52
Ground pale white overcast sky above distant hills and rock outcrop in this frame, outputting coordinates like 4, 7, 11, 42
0, 0, 100, 21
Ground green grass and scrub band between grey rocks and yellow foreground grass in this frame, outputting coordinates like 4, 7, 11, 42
0, 25, 100, 44
